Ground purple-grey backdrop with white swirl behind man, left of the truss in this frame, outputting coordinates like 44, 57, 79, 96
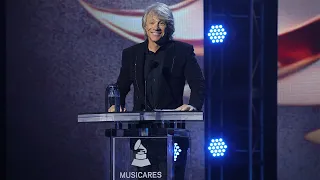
6, 0, 204, 180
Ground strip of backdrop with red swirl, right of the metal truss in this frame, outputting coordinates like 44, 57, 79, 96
278, 0, 320, 180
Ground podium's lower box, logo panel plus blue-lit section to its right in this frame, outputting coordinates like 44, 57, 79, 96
112, 131, 190, 180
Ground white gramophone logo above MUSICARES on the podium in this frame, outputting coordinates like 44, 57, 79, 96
131, 139, 151, 167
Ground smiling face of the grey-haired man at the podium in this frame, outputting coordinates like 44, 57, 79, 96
145, 12, 167, 42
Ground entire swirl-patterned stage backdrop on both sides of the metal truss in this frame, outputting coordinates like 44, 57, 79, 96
6, 0, 320, 180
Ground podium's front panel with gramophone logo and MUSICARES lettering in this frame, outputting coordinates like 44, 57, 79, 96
112, 137, 173, 180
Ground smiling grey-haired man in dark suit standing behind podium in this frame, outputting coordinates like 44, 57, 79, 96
109, 3, 205, 112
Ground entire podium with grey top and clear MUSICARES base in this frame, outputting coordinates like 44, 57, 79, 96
78, 111, 203, 180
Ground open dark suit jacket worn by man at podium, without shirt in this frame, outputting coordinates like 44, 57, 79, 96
117, 40, 205, 111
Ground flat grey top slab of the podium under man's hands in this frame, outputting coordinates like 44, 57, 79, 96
78, 111, 203, 122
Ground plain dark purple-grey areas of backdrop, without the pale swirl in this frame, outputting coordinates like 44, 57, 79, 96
6, 0, 320, 180
